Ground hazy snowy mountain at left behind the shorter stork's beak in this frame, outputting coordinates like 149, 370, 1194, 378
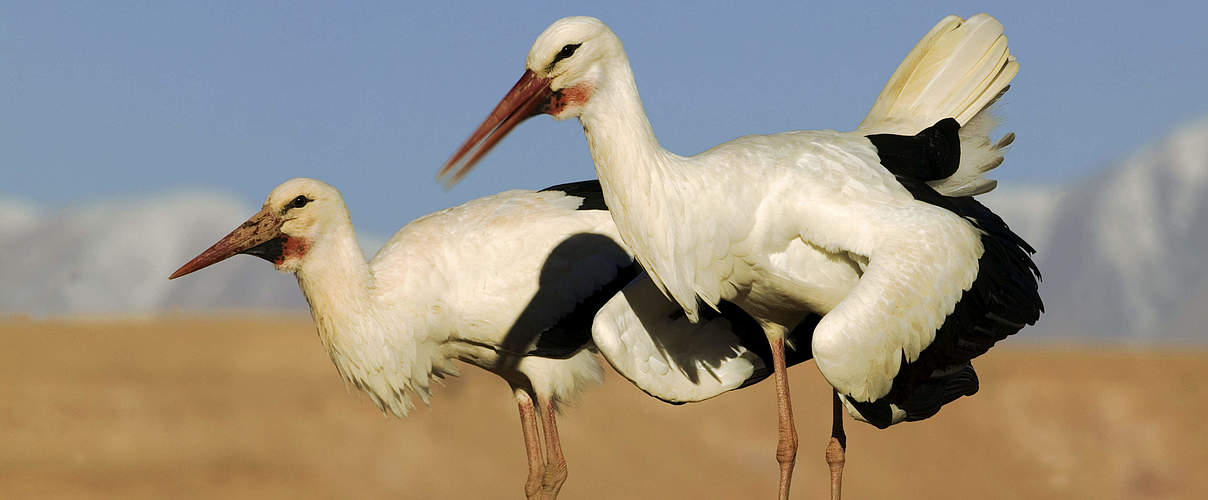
0, 193, 306, 315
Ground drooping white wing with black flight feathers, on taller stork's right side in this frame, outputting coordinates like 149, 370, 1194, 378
813, 178, 1044, 428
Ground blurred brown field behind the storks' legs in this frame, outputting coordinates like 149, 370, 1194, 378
0, 316, 1208, 499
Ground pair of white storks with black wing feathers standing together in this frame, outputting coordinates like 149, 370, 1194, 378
173, 14, 1041, 499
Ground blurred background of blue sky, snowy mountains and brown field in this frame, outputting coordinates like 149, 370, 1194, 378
0, 1, 1208, 499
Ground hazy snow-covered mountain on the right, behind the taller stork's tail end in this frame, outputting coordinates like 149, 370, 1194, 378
985, 117, 1208, 341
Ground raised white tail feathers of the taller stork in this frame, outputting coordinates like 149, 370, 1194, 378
858, 13, 1020, 196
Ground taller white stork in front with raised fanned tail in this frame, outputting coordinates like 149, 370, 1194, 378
440, 14, 1043, 498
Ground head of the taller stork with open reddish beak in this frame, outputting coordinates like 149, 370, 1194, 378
437, 17, 627, 185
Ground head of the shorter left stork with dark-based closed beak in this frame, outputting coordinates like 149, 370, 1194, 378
168, 178, 348, 279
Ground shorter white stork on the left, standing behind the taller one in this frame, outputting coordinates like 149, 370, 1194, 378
173, 179, 631, 496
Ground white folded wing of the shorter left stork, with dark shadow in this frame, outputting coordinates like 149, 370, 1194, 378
371, 181, 637, 357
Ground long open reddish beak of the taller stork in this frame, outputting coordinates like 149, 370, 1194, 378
436, 70, 553, 188
